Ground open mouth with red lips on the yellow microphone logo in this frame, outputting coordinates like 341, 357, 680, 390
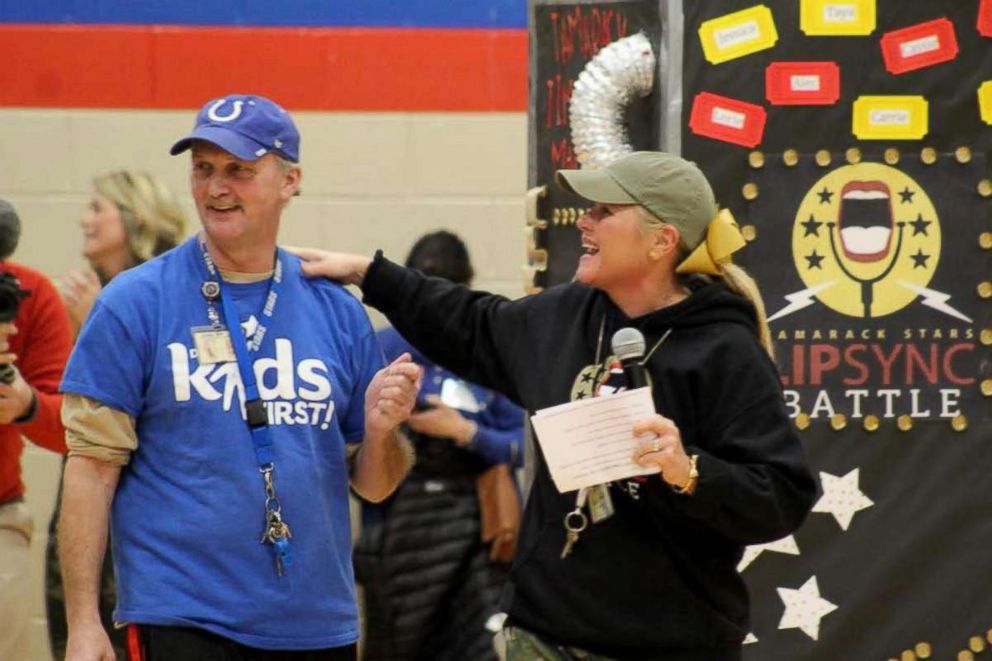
837, 181, 895, 262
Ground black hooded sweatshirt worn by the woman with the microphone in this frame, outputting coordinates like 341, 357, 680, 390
362, 255, 816, 661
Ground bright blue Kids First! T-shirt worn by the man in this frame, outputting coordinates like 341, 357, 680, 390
62, 239, 383, 650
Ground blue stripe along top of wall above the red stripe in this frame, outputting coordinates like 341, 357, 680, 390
0, 0, 527, 29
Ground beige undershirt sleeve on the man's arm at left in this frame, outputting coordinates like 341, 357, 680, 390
62, 393, 138, 466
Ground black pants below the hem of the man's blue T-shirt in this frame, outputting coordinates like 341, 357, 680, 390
127, 624, 358, 661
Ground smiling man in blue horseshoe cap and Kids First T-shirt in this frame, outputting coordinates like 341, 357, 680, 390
60, 95, 421, 661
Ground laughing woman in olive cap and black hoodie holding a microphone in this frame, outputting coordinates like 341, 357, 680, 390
292, 152, 816, 661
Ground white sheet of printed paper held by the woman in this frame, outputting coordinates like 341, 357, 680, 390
531, 388, 660, 493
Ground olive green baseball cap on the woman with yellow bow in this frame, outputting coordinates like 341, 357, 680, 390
557, 151, 717, 250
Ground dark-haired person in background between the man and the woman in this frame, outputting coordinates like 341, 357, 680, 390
355, 231, 524, 661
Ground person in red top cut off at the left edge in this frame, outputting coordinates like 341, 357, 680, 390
0, 200, 72, 659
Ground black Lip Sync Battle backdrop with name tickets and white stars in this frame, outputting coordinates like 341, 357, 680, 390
682, 0, 992, 661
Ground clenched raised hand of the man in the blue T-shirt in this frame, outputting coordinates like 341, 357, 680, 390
365, 353, 423, 441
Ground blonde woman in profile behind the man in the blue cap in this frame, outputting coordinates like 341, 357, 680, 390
45, 170, 188, 659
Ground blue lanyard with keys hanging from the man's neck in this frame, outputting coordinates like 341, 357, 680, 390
199, 237, 293, 576
